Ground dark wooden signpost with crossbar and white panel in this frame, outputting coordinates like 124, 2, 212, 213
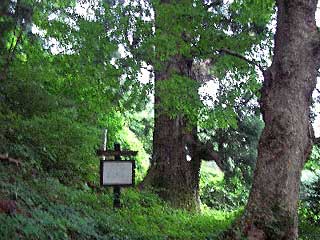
97, 144, 138, 208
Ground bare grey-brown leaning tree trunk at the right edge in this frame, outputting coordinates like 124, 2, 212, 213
233, 0, 319, 240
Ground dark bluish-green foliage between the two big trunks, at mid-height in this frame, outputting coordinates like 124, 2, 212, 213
199, 111, 264, 186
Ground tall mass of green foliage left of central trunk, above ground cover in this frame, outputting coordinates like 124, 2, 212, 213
0, 0, 148, 184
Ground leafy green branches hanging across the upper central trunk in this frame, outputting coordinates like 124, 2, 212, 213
108, 0, 274, 131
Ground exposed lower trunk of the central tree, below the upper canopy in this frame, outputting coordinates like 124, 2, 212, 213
142, 56, 201, 210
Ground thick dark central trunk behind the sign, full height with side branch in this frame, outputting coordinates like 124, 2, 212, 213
141, 0, 221, 210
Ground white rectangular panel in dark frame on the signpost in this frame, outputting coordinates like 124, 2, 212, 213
101, 160, 134, 186
